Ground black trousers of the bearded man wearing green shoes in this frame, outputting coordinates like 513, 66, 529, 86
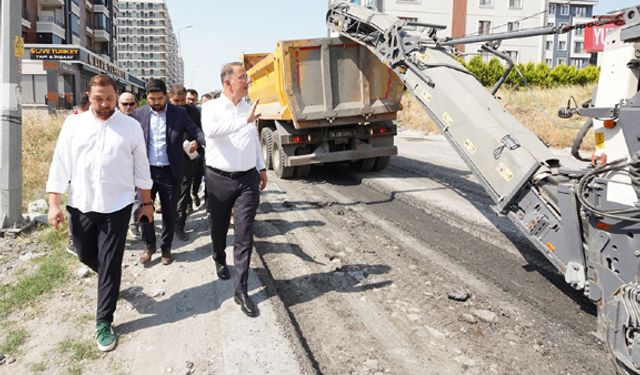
67, 205, 132, 323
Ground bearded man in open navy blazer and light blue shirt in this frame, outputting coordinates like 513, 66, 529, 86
133, 79, 205, 265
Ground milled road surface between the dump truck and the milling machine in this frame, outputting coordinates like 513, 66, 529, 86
251, 131, 612, 374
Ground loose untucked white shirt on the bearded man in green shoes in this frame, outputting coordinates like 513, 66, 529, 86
47, 110, 153, 213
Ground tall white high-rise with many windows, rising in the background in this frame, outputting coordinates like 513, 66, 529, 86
117, 0, 184, 85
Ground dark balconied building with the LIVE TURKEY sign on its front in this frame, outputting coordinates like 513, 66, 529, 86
21, 0, 143, 110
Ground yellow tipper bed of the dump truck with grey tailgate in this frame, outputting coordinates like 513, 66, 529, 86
243, 38, 404, 129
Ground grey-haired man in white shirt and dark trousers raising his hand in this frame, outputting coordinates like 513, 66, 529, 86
202, 62, 267, 317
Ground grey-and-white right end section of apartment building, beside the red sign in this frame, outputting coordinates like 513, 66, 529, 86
544, 0, 598, 68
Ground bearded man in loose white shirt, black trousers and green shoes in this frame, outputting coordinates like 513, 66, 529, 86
46, 74, 153, 351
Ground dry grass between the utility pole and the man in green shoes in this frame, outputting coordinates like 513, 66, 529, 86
22, 112, 65, 209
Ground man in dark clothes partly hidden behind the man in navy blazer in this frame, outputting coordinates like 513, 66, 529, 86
169, 85, 204, 241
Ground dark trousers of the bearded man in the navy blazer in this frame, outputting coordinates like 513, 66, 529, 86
141, 167, 180, 251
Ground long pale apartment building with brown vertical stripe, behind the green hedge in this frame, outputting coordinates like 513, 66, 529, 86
344, 0, 598, 66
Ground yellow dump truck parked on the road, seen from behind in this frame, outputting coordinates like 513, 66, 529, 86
242, 38, 404, 179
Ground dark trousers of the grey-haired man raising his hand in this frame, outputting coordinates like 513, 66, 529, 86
205, 167, 260, 293
